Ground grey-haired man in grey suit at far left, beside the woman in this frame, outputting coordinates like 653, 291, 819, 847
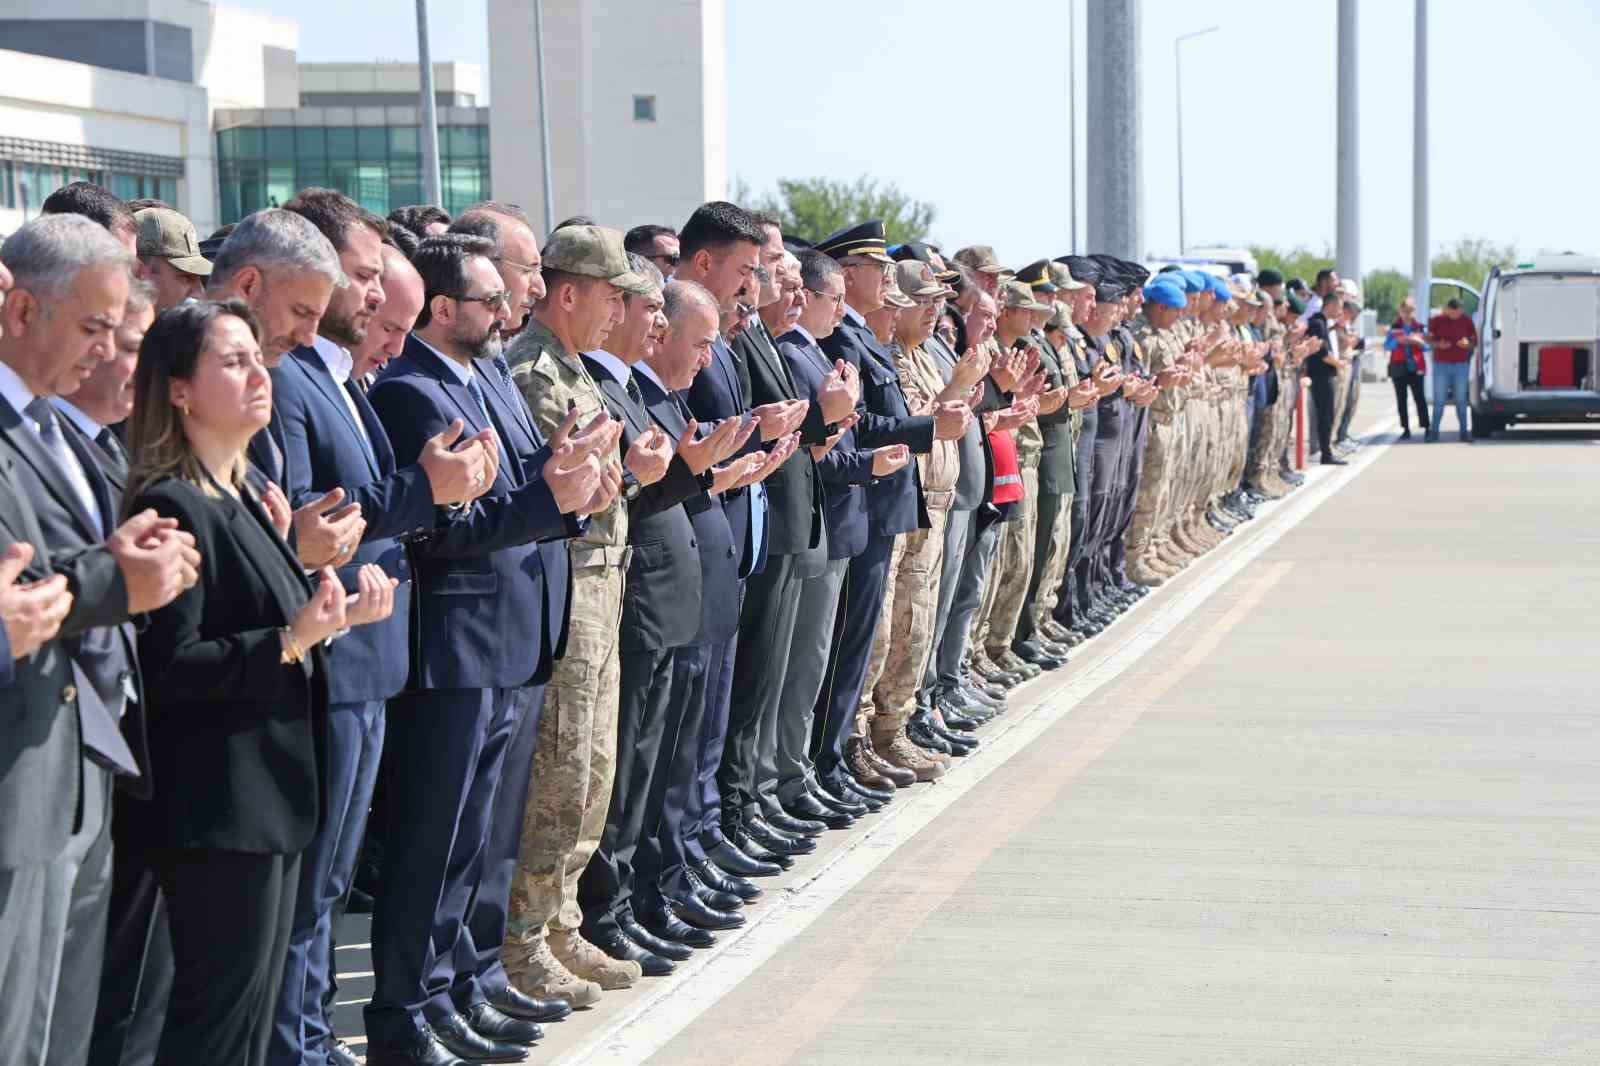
0, 214, 198, 1063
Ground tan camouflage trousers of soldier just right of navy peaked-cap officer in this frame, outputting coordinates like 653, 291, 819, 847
856, 493, 950, 736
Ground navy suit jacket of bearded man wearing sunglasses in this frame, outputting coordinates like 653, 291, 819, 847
368, 336, 582, 690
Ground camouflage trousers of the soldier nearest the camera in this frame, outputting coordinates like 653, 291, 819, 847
504, 560, 624, 947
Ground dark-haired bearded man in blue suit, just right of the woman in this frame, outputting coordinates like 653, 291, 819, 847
267, 190, 496, 1066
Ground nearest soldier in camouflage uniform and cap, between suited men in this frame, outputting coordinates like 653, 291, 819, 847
504, 226, 651, 1004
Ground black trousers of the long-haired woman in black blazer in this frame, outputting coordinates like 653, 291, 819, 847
149, 848, 299, 1066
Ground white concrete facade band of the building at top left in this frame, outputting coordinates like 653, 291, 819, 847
0, 50, 216, 234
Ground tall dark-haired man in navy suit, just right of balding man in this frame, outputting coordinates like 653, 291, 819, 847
674, 202, 806, 874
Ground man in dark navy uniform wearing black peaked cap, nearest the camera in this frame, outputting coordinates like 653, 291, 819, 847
816, 219, 971, 800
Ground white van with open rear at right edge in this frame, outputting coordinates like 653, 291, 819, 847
1472, 254, 1600, 437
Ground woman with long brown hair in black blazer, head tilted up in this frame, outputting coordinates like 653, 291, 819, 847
115, 301, 394, 1066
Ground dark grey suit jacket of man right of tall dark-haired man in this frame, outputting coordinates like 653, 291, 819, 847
733, 319, 832, 576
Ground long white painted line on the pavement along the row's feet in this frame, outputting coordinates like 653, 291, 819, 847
555, 419, 1400, 1066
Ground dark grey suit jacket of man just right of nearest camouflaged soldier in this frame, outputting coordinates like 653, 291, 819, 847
581, 355, 702, 651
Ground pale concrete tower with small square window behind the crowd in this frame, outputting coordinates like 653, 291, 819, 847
488, 0, 728, 229
